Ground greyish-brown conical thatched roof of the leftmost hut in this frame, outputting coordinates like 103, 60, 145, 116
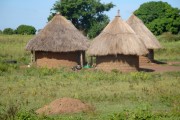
26, 14, 88, 52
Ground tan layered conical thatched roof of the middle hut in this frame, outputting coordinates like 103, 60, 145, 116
88, 12, 148, 56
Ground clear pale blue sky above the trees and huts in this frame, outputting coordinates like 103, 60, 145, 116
0, 0, 180, 30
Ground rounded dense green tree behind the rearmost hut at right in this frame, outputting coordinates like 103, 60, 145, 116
134, 1, 180, 35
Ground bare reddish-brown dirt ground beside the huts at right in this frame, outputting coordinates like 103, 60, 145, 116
140, 62, 180, 72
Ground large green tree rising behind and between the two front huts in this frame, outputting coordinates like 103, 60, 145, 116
48, 0, 114, 38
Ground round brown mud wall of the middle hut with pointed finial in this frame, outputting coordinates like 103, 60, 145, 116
96, 55, 139, 72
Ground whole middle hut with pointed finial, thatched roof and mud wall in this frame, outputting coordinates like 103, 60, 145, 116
88, 12, 148, 72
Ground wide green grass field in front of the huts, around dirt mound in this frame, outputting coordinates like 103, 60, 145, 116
0, 66, 180, 119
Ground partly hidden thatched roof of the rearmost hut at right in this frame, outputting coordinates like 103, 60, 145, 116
127, 15, 161, 49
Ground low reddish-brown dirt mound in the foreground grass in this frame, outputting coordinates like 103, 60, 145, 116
36, 98, 93, 115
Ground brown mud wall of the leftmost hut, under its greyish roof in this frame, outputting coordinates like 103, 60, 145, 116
35, 51, 80, 68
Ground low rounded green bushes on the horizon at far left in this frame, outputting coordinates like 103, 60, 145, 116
0, 25, 36, 35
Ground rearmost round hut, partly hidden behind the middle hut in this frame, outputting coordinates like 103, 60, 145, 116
127, 14, 161, 65
